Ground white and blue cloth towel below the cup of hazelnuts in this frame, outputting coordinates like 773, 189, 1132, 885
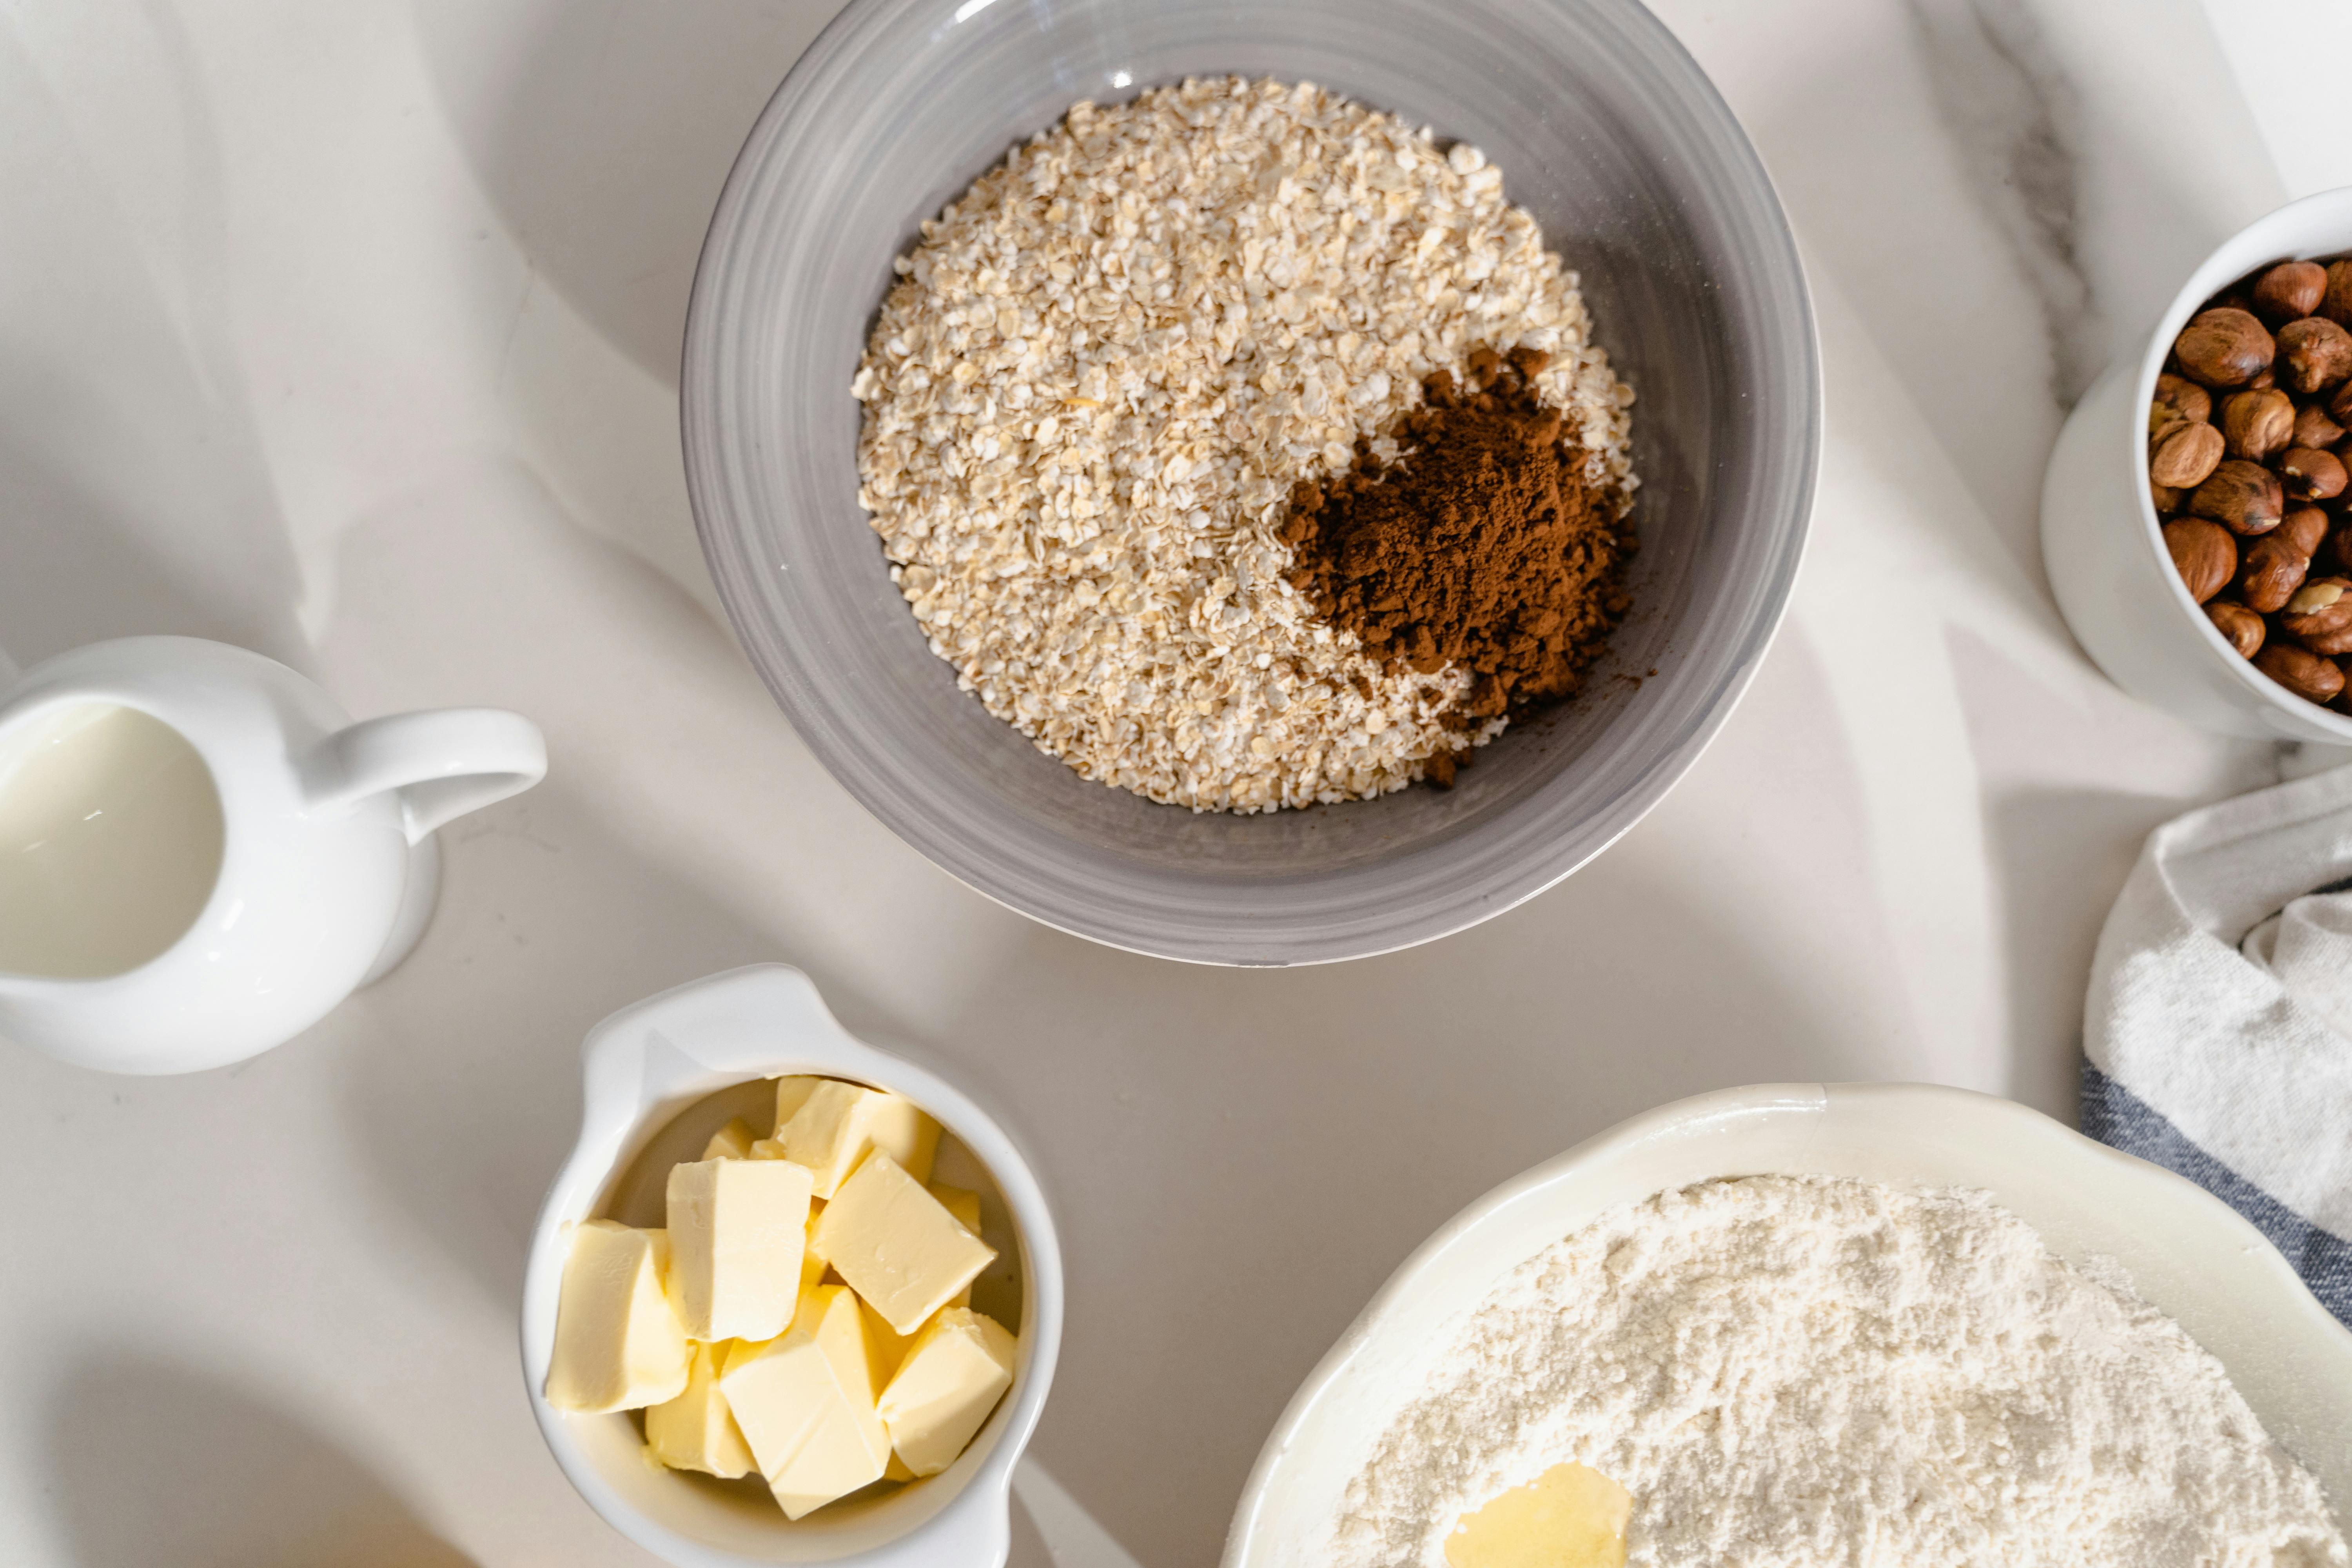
2082, 766, 2352, 1326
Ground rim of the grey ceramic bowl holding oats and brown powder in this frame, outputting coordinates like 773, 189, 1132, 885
680, 0, 1825, 966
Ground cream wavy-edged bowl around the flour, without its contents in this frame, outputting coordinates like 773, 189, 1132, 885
1225, 1084, 2352, 1568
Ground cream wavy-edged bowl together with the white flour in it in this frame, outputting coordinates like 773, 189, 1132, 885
1225, 1084, 2352, 1568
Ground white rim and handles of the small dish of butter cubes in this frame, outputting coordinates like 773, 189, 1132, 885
517, 964, 1065, 1568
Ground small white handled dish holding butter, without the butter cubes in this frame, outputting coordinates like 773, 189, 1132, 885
522, 964, 1063, 1568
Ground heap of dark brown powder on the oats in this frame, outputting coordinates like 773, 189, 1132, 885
1282, 348, 1635, 783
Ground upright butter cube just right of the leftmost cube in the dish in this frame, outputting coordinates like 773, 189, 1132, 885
670, 1159, 809, 1340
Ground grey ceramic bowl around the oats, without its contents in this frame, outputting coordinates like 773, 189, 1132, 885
682, 0, 1820, 964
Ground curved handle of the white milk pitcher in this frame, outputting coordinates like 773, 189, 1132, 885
303, 708, 548, 844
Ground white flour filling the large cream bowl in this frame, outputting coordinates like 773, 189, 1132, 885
1327, 1176, 2347, 1568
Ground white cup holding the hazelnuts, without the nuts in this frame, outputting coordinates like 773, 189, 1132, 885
2042, 188, 2352, 745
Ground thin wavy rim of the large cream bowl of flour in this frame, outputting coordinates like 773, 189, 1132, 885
1221, 1084, 2352, 1568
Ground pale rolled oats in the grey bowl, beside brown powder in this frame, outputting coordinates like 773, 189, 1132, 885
851, 78, 1632, 811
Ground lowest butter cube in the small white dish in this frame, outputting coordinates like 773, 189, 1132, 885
720, 1286, 889, 1519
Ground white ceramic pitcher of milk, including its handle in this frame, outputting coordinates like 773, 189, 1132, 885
0, 637, 548, 1072
